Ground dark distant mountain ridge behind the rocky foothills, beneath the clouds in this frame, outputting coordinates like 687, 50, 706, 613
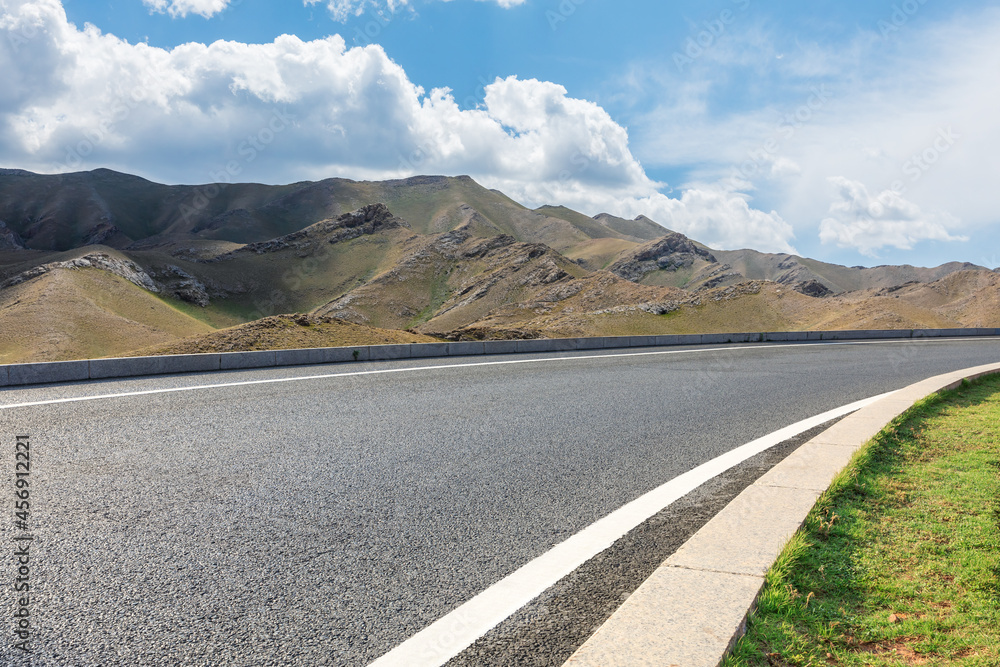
0, 169, 662, 252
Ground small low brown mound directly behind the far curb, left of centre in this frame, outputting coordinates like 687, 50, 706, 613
122, 315, 439, 357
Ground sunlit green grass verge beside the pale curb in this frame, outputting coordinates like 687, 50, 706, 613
723, 376, 1000, 667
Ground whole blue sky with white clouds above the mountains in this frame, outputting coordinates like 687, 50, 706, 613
0, 0, 1000, 268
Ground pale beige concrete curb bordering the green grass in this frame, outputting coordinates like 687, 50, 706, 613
566, 364, 1000, 667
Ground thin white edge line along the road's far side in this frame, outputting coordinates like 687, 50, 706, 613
0, 338, 988, 410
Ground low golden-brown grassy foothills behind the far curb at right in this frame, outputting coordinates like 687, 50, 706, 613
454, 271, 1000, 338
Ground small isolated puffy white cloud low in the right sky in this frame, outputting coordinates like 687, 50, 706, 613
820, 176, 968, 257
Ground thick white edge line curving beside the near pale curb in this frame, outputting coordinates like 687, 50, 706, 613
369, 391, 896, 667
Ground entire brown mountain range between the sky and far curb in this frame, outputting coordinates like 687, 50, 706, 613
0, 170, 1000, 363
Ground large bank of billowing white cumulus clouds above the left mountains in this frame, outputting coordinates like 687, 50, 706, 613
0, 0, 793, 252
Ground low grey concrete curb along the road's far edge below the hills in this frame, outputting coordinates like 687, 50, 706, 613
0, 329, 1000, 387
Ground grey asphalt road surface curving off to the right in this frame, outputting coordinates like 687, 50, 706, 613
0, 340, 1000, 666
